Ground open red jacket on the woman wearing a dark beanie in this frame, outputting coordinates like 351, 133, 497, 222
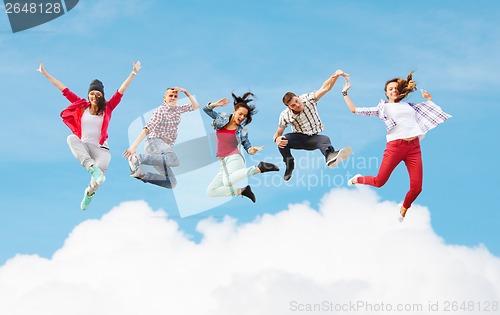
61, 88, 123, 145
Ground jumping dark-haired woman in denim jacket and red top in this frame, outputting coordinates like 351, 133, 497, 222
203, 92, 279, 202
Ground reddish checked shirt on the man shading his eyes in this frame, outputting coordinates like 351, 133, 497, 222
144, 103, 194, 146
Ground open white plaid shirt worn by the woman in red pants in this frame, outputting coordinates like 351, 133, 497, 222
355, 100, 451, 134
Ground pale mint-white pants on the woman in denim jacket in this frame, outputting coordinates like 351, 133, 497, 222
207, 154, 257, 197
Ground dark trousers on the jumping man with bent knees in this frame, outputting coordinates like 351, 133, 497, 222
279, 133, 335, 163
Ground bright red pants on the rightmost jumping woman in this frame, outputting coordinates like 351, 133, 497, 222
358, 138, 423, 209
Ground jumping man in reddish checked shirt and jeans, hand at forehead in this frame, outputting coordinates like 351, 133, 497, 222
123, 87, 200, 189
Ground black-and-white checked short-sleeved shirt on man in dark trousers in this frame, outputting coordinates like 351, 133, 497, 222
278, 91, 323, 136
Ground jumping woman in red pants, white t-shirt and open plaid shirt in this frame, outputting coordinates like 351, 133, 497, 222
342, 72, 451, 222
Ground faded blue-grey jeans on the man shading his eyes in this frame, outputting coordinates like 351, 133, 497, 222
138, 138, 179, 189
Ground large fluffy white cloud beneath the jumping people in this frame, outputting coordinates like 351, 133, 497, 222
0, 187, 500, 315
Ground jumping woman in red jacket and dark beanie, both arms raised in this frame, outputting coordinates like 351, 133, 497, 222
38, 61, 141, 210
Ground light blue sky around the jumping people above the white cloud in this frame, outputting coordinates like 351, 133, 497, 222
0, 0, 500, 264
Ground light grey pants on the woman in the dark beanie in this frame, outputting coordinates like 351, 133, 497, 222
67, 135, 111, 194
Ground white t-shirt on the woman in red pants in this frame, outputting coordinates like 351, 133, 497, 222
385, 102, 424, 142
